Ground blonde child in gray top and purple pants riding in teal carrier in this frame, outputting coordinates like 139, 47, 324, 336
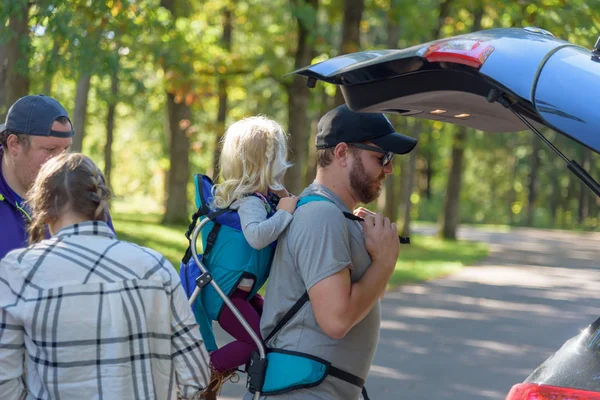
209, 116, 298, 392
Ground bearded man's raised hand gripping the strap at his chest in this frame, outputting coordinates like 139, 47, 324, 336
361, 210, 400, 270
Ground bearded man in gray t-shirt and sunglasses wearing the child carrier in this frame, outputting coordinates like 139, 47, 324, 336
246, 105, 417, 400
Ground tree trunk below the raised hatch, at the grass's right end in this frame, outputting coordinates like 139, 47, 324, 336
441, 126, 467, 240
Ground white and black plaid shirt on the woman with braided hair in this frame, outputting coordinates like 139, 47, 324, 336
0, 222, 210, 400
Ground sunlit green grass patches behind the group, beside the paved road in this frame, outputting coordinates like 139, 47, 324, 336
112, 211, 488, 287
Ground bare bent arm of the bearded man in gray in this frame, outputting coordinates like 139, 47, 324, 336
308, 214, 399, 339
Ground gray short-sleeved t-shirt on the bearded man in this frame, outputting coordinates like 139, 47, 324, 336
245, 182, 380, 400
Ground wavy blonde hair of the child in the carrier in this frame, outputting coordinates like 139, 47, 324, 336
213, 115, 291, 208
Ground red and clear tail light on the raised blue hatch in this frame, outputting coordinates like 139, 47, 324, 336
423, 39, 494, 68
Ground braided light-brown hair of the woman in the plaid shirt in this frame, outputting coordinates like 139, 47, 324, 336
26, 153, 111, 243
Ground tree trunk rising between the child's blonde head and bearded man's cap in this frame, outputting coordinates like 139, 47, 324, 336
285, 0, 319, 195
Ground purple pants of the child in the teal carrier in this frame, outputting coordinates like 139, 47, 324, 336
210, 289, 264, 372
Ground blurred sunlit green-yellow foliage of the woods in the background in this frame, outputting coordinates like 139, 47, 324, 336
5, 0, 600, 229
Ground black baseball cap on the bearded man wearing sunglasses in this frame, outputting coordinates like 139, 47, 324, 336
316, 104, 417, 154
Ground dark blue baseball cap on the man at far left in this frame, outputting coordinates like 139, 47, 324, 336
0, 94, 75, 138
